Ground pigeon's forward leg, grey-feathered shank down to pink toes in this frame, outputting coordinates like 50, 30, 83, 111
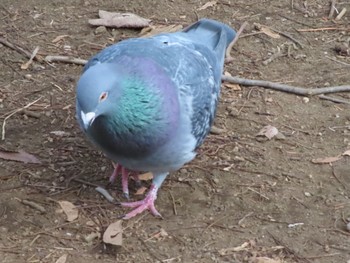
121, 173, 168, 219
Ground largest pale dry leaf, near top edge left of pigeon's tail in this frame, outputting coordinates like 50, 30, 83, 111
89, 10, 151, 28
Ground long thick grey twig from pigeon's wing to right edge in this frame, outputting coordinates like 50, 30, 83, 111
222, 76, 350, 96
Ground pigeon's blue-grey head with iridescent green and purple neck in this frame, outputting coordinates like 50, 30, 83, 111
76, 60, 179, 157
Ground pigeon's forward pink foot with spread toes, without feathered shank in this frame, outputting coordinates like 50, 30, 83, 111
121, 184, 162, 219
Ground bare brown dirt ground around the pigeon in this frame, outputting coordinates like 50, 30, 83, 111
0, 0, 350, 263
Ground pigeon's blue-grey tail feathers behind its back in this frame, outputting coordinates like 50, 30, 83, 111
183, 19, 236, 50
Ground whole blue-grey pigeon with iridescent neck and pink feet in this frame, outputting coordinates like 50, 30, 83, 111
76, 19, 236, 219
